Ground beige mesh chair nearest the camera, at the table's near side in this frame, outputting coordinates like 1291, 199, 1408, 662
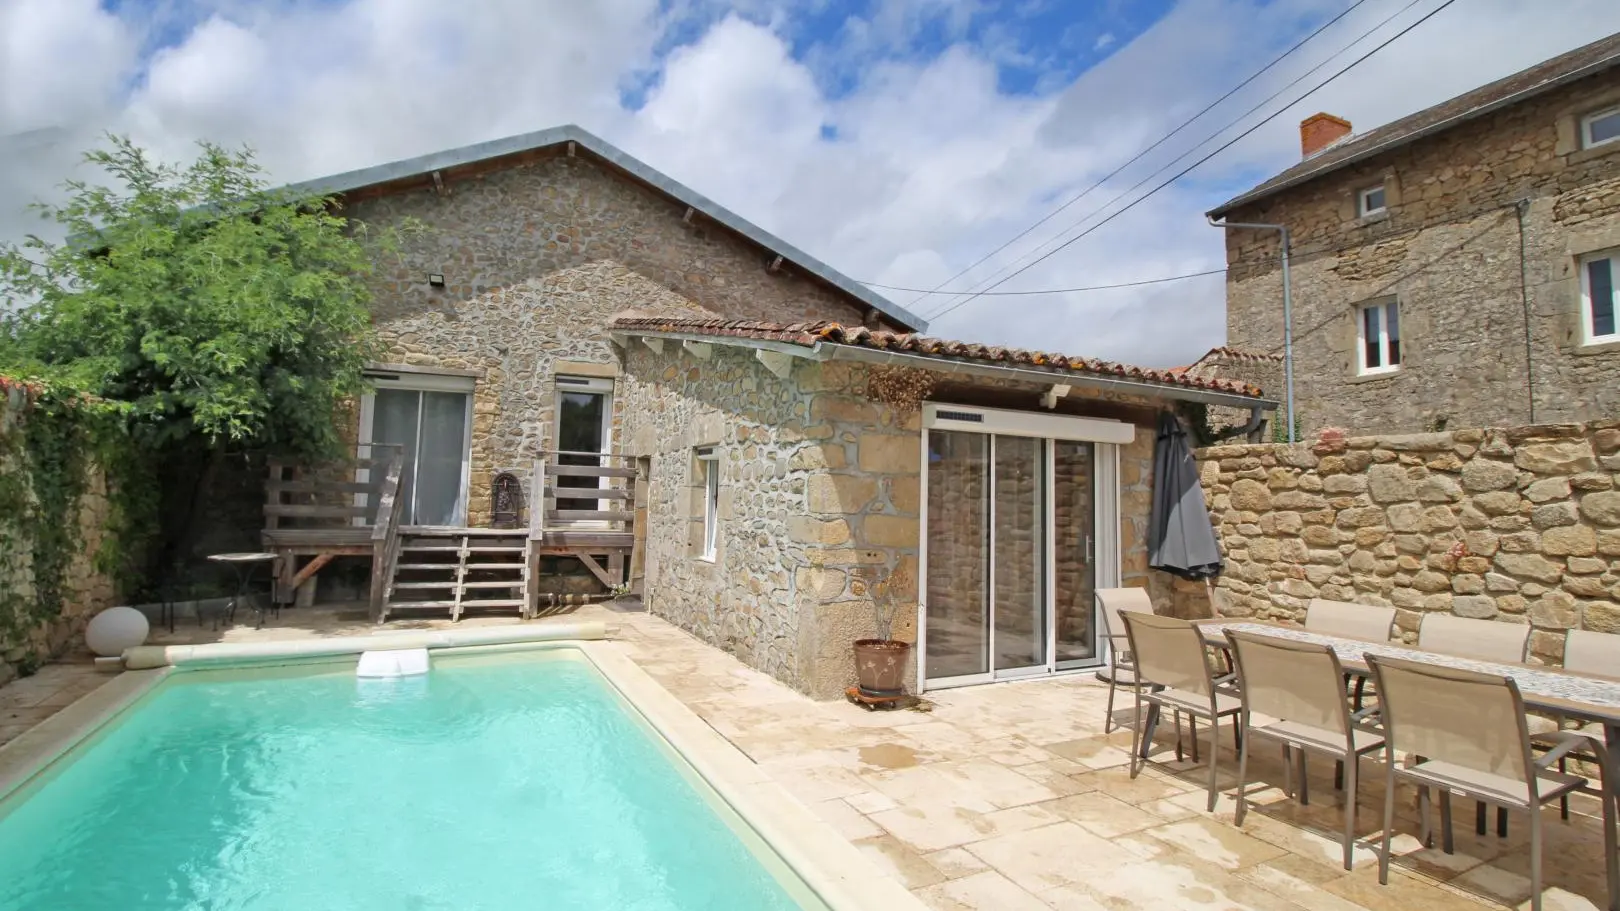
1367, 655, 1620, 911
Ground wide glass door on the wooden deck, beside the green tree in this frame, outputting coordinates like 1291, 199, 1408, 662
360, 373, 473, 525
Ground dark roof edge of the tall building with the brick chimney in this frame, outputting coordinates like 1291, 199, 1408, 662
1210, 32, 1620, 219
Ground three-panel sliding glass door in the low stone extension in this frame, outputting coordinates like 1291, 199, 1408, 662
922, 414, 1111, 687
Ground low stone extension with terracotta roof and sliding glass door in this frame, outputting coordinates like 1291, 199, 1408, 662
612, 316, 1272, 699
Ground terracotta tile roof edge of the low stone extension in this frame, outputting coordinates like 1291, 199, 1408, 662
611, 316, 1262, 397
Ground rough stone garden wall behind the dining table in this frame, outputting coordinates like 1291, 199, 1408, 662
1199, 421, 1620, 663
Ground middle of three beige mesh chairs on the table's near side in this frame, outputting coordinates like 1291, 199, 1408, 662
1226, 629, 1383, 870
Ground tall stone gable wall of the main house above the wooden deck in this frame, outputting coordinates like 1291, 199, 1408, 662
345, 156, 860, 524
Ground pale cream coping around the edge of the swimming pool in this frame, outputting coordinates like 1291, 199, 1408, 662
0, 627, 925, 911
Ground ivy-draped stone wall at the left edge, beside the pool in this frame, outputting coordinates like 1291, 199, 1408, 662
0, 386, 117, 684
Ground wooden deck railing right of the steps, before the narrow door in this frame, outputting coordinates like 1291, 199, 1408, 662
528, 449, 635, 540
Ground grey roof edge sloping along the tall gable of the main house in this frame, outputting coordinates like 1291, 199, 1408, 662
288, 123, 928, 332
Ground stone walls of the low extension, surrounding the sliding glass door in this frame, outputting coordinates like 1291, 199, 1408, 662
620, 340, 1186, 699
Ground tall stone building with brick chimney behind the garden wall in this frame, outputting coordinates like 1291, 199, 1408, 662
1209, 34, 1620, 436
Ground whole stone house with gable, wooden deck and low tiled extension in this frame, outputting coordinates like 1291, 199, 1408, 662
266, 126, 1275, 697
